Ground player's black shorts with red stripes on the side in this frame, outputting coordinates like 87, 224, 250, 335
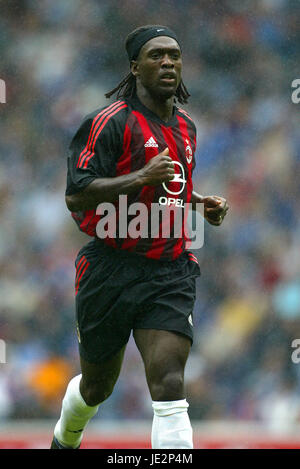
75, 240, 200, 363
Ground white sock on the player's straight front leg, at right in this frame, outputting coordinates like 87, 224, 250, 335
151, 399, 193, 449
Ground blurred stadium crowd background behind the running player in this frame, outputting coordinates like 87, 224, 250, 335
0, 0, 300, 448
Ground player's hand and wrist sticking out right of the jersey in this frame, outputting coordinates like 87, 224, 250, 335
191, 191, 229, 226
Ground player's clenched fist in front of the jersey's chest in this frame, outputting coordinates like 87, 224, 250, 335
140, 147, 175, 186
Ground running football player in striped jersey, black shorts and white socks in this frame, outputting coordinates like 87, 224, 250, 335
51, 25, 228, 449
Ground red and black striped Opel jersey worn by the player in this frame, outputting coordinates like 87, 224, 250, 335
66, 96, 196, 260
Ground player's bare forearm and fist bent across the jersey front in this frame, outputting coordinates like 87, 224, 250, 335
66, 148, 174, 212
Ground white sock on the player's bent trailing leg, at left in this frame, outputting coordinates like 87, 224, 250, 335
54, 375, 99, 448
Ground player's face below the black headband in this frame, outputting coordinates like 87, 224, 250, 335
131, 36, 182, 99
